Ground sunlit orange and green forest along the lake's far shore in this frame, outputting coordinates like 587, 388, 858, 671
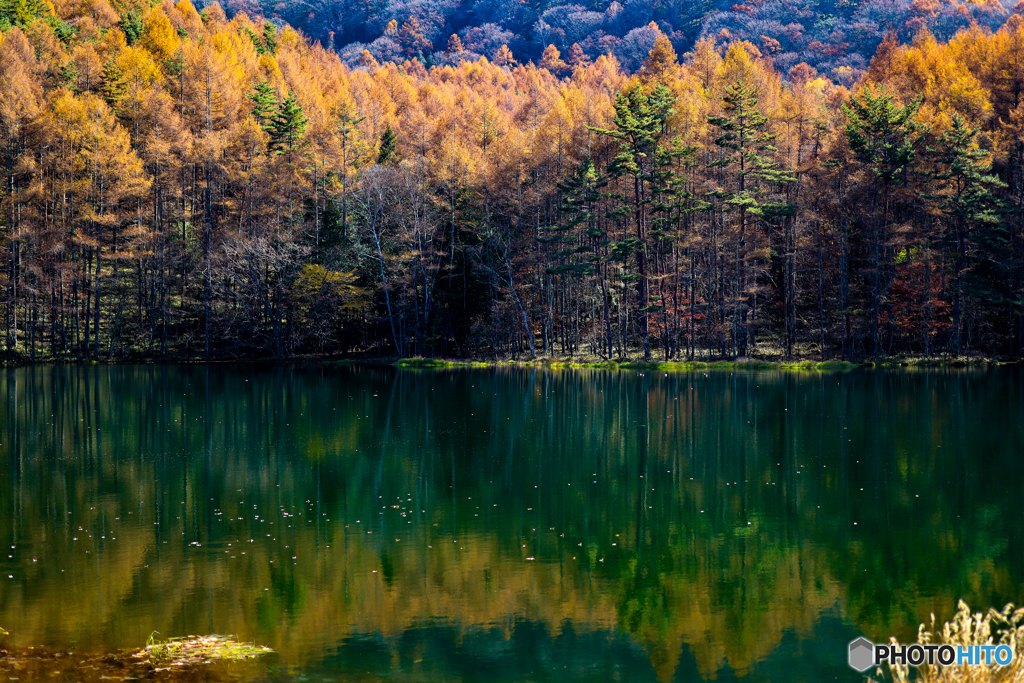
0, 0, 1024, 361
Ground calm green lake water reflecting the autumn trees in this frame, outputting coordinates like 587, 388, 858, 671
0, 366, 1024, 683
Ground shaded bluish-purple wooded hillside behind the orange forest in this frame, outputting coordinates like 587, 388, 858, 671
232, 0, 1015, 86
